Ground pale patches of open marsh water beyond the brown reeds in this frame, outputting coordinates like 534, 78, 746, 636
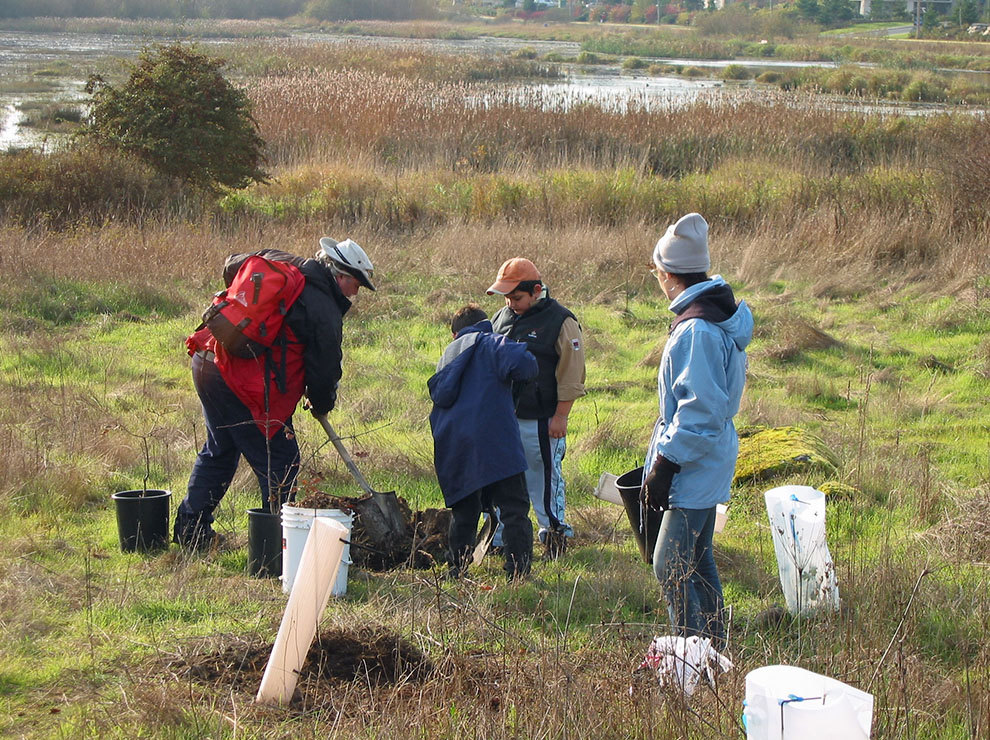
0, 30, 984, 151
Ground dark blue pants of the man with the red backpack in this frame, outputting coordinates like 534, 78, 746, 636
175, 354, 299, 534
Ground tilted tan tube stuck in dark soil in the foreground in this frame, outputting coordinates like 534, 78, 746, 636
255, 519, 347, 704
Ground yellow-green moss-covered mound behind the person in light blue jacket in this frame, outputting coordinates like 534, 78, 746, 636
732, 427, 838, 485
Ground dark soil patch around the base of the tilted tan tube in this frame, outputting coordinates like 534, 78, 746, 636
169, 627, 433, 691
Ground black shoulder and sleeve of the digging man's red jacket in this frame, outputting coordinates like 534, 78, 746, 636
224, 249, 351, 421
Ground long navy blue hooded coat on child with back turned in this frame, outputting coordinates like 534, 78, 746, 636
427, 321, 537, 506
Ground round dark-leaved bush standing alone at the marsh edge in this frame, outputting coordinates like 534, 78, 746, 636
83, 44, 268, 190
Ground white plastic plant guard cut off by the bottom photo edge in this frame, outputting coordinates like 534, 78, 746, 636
743, 665, 873, 740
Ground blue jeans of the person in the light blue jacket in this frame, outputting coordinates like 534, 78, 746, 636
653, 506, 725, 650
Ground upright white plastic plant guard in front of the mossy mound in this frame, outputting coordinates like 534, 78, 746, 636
763, 486, 839, 616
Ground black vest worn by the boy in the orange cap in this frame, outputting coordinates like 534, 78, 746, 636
492, 298, 577, 419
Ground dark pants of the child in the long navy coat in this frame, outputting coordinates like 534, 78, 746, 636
447, 473, 533, 578
